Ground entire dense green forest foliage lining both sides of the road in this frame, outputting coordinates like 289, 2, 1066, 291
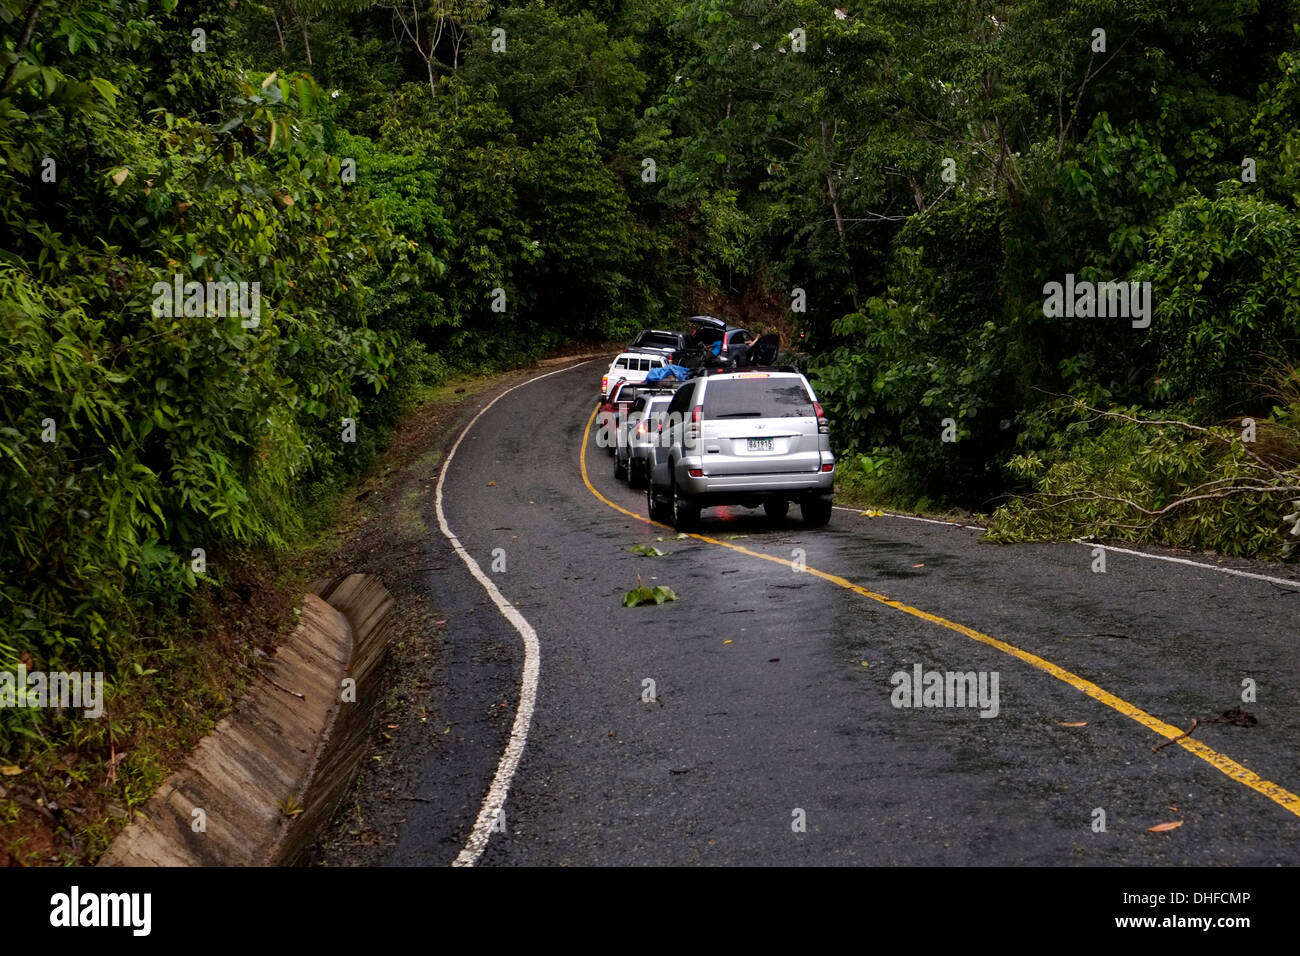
0, 0, 1300, 749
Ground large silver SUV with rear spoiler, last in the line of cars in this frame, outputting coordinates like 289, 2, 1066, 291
646, 368, 835, 531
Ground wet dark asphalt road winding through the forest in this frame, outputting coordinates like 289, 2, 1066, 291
389, 363, 1300, 865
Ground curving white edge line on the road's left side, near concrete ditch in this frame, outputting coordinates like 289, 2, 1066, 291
434, 359, 598, 866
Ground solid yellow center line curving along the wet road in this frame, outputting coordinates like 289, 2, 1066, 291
579, 407, 1300, 817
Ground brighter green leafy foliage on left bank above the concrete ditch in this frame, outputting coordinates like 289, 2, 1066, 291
0, 1, 413, 702
